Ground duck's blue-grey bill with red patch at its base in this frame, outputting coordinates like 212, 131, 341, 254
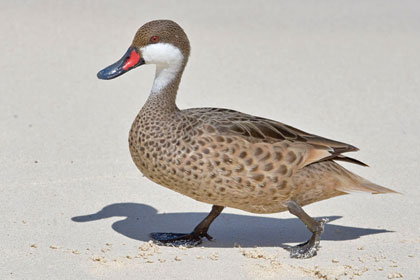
97, 47, 144, 80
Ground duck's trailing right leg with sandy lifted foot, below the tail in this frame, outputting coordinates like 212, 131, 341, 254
287, 200, 328, 259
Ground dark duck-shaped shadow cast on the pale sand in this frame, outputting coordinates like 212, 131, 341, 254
72, 203, 391, 247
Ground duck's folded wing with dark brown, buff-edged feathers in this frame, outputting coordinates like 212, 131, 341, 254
185, 108, 366, 166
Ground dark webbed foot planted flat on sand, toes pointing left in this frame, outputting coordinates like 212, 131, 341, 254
150, 232, 213, 247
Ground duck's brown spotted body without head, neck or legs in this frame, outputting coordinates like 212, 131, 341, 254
129, 103, 388, 213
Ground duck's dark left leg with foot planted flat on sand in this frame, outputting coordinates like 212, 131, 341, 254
150, 205, 224, 246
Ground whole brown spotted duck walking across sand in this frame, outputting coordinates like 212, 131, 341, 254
98, 21, 393, 257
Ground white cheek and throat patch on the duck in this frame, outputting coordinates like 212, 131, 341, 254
140, 43, 184, 93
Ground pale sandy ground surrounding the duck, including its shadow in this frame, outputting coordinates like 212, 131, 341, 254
0, 0, 420, 279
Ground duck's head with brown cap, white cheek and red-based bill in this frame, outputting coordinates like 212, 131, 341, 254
97, 20, 190, 80
